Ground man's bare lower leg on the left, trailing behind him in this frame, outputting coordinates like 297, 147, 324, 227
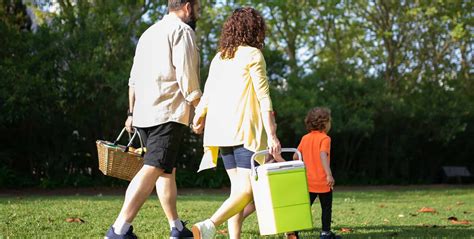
117, 165, 163, 223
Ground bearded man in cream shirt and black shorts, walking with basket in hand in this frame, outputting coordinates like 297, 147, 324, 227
105, 0, 202, 239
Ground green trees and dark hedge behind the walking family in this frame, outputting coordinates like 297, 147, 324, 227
0, 0, 474, 187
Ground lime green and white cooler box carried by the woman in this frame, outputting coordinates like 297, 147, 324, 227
251, 148, 313, 235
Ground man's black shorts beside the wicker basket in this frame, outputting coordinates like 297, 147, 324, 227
138, 122, 186, 174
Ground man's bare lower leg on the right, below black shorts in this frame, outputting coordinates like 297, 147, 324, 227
156, 168, 178, 221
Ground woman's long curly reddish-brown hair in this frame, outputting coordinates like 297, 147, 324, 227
219, 7, 266, 59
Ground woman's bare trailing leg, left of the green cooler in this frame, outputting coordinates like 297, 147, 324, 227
211, 168, 253, 227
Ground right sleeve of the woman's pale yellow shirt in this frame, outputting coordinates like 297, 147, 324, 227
249, 49, 273, 112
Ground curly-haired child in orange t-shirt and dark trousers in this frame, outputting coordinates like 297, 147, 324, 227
293, 107, 340, 239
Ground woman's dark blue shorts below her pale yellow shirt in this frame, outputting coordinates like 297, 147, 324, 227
219, 145, 253, 169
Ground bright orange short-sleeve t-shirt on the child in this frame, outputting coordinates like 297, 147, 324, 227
298, 131, 331, 193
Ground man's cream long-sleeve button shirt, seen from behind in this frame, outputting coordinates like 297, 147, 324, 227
128, 13, 202, 127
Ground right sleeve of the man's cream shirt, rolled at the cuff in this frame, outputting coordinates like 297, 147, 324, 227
172, 28, 202, 102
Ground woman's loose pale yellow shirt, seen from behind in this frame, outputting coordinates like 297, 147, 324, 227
196, 46, 273, 172
